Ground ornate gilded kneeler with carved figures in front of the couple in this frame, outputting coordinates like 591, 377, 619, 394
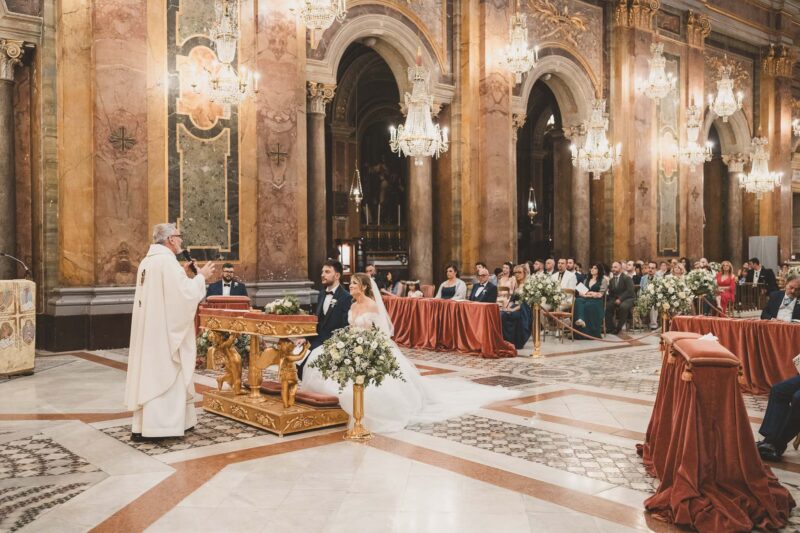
198, 308, 349, 437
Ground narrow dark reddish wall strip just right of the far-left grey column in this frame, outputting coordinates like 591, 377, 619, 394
13, 66, 33, 278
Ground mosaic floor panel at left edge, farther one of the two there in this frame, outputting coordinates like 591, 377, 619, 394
0, 433, 99, 479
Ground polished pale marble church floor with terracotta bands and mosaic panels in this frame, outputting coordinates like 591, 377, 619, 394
0, 336, 800, 533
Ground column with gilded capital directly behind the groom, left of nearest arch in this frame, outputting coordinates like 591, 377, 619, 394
306, 81, 336, 280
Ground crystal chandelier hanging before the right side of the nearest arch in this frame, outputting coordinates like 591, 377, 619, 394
389, 51, 448, 166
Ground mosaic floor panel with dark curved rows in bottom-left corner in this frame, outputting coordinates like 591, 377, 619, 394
0, 483, 91, 532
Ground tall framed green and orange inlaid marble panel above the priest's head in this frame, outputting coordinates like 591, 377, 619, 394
166, 0, 239, 260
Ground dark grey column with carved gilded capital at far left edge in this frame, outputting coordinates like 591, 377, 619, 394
0, 39, 23, 279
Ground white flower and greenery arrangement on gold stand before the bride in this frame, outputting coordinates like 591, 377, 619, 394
309, 325, 405, 391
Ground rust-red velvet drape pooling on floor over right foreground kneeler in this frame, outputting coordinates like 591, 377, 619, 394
644, 356, 795, 532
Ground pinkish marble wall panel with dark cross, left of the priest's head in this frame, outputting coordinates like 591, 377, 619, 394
93, 0, 150, 285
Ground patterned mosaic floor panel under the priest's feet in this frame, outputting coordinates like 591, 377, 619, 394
102, 411, 268, 456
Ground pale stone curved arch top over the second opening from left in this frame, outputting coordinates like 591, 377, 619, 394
512, 55, 596, 126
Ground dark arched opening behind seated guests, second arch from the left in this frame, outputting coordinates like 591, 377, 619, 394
517, 81, 571, 261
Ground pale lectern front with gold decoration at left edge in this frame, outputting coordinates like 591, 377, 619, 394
0, 279, 36, 376
